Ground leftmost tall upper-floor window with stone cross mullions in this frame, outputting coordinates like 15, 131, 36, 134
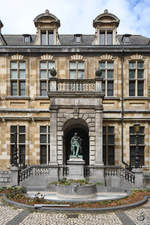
10, 61, 26, 96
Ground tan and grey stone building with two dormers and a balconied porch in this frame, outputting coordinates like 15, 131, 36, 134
0, 10, 150, 170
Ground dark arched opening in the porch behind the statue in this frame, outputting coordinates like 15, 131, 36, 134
63, 119, 89, 165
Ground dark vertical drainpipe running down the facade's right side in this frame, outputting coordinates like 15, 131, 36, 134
121, 48, 129, 167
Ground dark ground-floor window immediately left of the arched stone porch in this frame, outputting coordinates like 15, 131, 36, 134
40, 126, 50, 164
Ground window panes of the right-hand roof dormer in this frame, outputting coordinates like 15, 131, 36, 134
99, 30, 113, 45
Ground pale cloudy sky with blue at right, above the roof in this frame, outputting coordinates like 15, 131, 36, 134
0, 0, 150, 37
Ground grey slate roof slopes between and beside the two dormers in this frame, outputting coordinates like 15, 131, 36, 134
3, 34, 150, 46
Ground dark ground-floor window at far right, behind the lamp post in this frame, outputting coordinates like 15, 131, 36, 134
130, 127, 144, 166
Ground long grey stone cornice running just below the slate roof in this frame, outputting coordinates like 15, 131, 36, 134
0, 45, 150, 56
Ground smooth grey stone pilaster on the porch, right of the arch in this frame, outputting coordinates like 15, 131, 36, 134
95, 109, 104, 166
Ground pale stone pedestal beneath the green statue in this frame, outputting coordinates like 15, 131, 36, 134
67, 156, 85, 180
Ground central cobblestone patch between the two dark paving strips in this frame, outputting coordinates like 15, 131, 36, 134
20, 213, 123, 225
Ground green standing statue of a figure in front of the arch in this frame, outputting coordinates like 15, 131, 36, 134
71, 132, 82, 157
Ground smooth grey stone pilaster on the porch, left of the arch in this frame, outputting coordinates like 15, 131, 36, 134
50, 109, 57, 165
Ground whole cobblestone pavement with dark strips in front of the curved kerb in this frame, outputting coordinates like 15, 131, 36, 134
0, 201, 150, 225
